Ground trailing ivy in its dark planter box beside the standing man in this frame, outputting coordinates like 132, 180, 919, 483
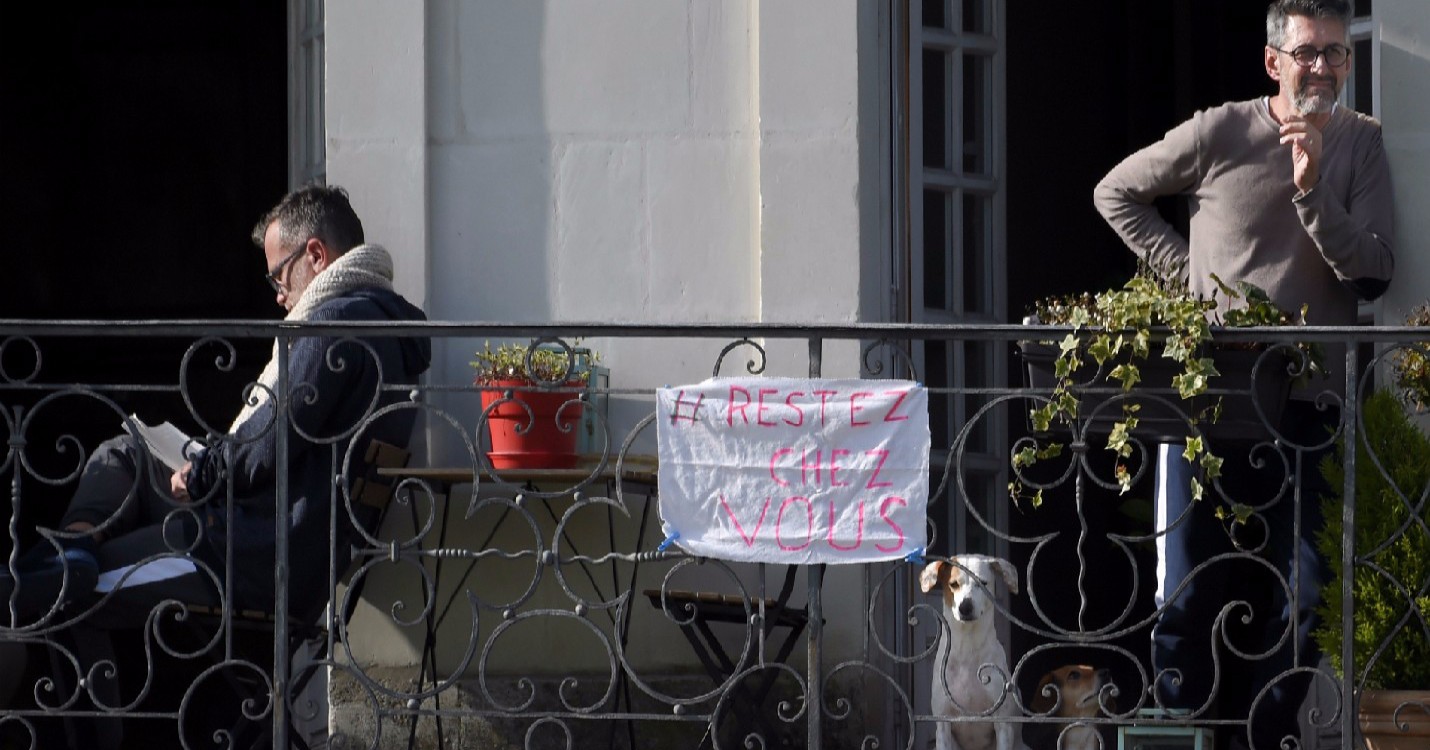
1010, 266, 1317, 505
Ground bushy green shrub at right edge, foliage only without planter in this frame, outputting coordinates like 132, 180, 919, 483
1314, 391, 1430, 690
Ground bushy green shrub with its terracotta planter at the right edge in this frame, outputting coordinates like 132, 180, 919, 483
1314, 319, 1430, 750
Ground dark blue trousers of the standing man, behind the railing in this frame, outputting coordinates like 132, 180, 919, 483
1153, 401, 1340, 747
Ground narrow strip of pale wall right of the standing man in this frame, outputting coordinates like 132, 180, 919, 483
1376, 0, 1430, 325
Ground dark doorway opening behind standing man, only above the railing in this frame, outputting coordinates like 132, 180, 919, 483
1007, 0, 1274, 321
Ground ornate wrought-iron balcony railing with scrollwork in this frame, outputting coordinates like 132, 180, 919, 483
0, 321, 1430, 749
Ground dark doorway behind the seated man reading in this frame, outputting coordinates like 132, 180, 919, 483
0, 0, 287, 528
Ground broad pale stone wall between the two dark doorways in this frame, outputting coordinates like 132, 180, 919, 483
326, 0, 888, 663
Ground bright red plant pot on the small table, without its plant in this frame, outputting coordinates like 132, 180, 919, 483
482, 381, 585, 471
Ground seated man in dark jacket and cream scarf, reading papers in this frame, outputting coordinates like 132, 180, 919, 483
0, 186, 430, 627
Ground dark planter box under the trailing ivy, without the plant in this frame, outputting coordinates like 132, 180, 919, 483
1018, 341, 1291, 442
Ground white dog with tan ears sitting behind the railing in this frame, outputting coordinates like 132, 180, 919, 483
918, 555, 1027, 750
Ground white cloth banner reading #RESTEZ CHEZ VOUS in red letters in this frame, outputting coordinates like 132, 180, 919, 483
656, 378, 930, 564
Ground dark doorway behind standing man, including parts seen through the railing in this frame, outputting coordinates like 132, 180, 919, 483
1007, 0, 1274, 704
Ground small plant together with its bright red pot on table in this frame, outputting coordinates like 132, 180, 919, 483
470, 341, 601, 469
